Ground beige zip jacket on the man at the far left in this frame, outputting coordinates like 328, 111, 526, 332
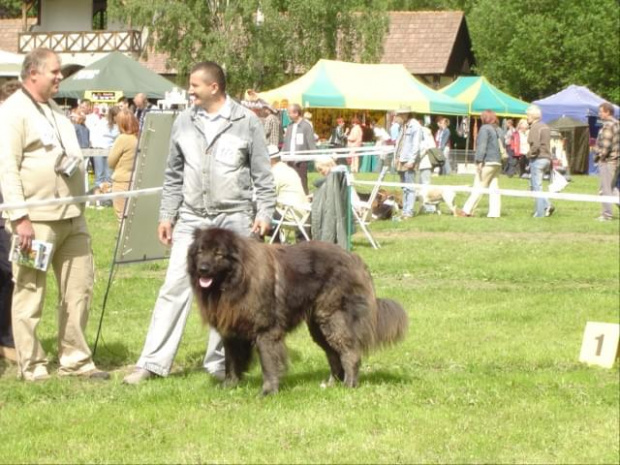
0, 90, 84, 221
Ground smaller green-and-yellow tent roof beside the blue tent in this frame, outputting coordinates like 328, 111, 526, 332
440, 76, 529, 118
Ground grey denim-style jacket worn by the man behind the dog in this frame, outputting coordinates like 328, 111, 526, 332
159, 97, 276, 222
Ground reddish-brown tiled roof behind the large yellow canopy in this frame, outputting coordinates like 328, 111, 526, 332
381, 11, 473, 75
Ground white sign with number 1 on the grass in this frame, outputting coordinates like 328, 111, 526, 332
579, 321, 620, 368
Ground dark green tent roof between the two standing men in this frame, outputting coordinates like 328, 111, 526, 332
56, 52, 174, 99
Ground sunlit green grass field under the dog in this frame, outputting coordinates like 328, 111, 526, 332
0, 175, 620, 463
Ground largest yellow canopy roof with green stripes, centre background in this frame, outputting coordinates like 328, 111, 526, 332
258, 60, 467, 115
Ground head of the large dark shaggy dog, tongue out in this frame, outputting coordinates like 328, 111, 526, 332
187, 228, 242, 291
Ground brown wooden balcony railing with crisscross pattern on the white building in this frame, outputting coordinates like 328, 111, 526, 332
19, 30, 142, 53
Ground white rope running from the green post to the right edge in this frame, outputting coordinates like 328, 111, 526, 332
351, 180, 620, 204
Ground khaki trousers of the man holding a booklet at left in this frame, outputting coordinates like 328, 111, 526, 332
7, 216, 95, 379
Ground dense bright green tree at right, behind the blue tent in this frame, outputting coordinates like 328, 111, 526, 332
468, 0, 620, 102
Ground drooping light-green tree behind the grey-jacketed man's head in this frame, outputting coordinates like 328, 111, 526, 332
109, 0, 387, 95
